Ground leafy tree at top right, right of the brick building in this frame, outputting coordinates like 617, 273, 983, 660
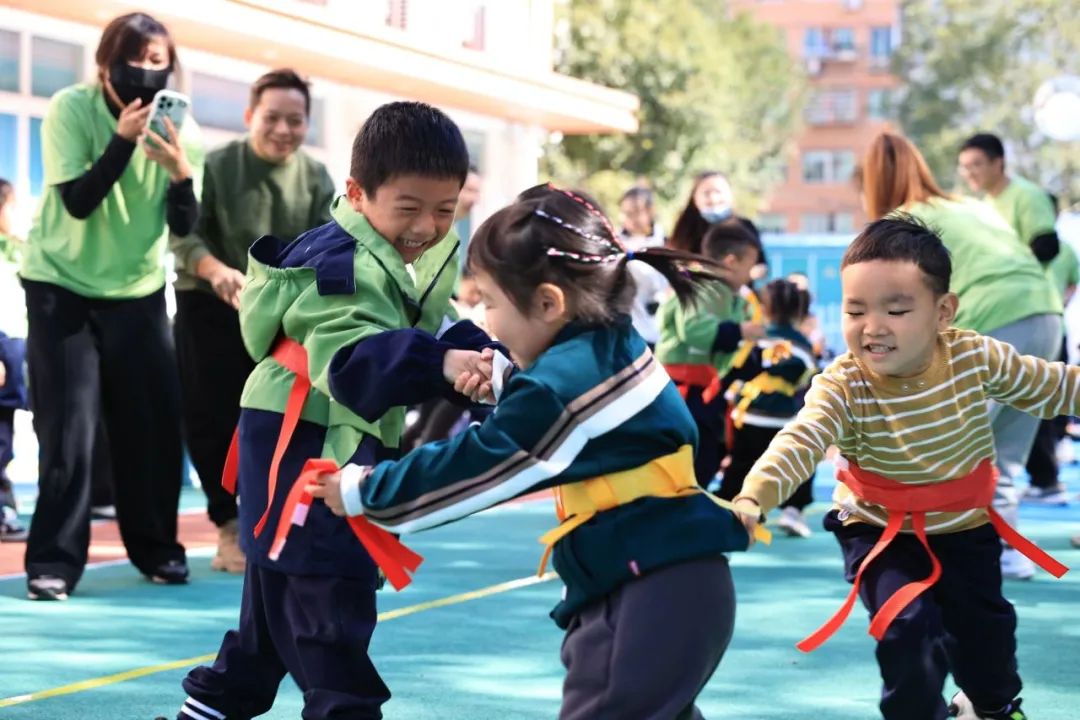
893, 0, 1080, 203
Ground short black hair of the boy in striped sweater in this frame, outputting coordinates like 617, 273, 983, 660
840, 213, 953, 296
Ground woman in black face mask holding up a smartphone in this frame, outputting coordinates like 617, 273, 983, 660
19, 13, 202, 600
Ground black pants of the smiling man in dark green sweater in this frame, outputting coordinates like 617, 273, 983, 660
174, 290, 255, 527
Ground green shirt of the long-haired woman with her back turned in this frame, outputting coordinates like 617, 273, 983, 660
904, 198, 1062, 335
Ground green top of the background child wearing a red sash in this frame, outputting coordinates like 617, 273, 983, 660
657, 283, 746, 376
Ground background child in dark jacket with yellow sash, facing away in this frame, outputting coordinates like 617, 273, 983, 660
717, 280, 816, 538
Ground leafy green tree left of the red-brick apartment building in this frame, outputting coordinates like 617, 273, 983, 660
542, 0, 806, 220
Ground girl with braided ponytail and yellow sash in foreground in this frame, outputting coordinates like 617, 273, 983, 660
311, 186, 760, 720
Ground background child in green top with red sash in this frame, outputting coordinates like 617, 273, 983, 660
657, 218, 765, 488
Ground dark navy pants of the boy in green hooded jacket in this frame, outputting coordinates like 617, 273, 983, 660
177, 561, 390, 720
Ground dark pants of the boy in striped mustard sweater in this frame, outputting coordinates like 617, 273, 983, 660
825, 511, 1021, 720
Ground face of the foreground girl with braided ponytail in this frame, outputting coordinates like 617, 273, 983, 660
473, 269, 568, 369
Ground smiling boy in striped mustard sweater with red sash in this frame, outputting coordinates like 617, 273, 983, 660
735, 216, 1080, 720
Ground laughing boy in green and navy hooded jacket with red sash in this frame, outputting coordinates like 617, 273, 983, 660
170, 103, 490, 720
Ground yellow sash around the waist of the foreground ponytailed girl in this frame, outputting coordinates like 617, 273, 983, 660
537, 445, 772, 575
